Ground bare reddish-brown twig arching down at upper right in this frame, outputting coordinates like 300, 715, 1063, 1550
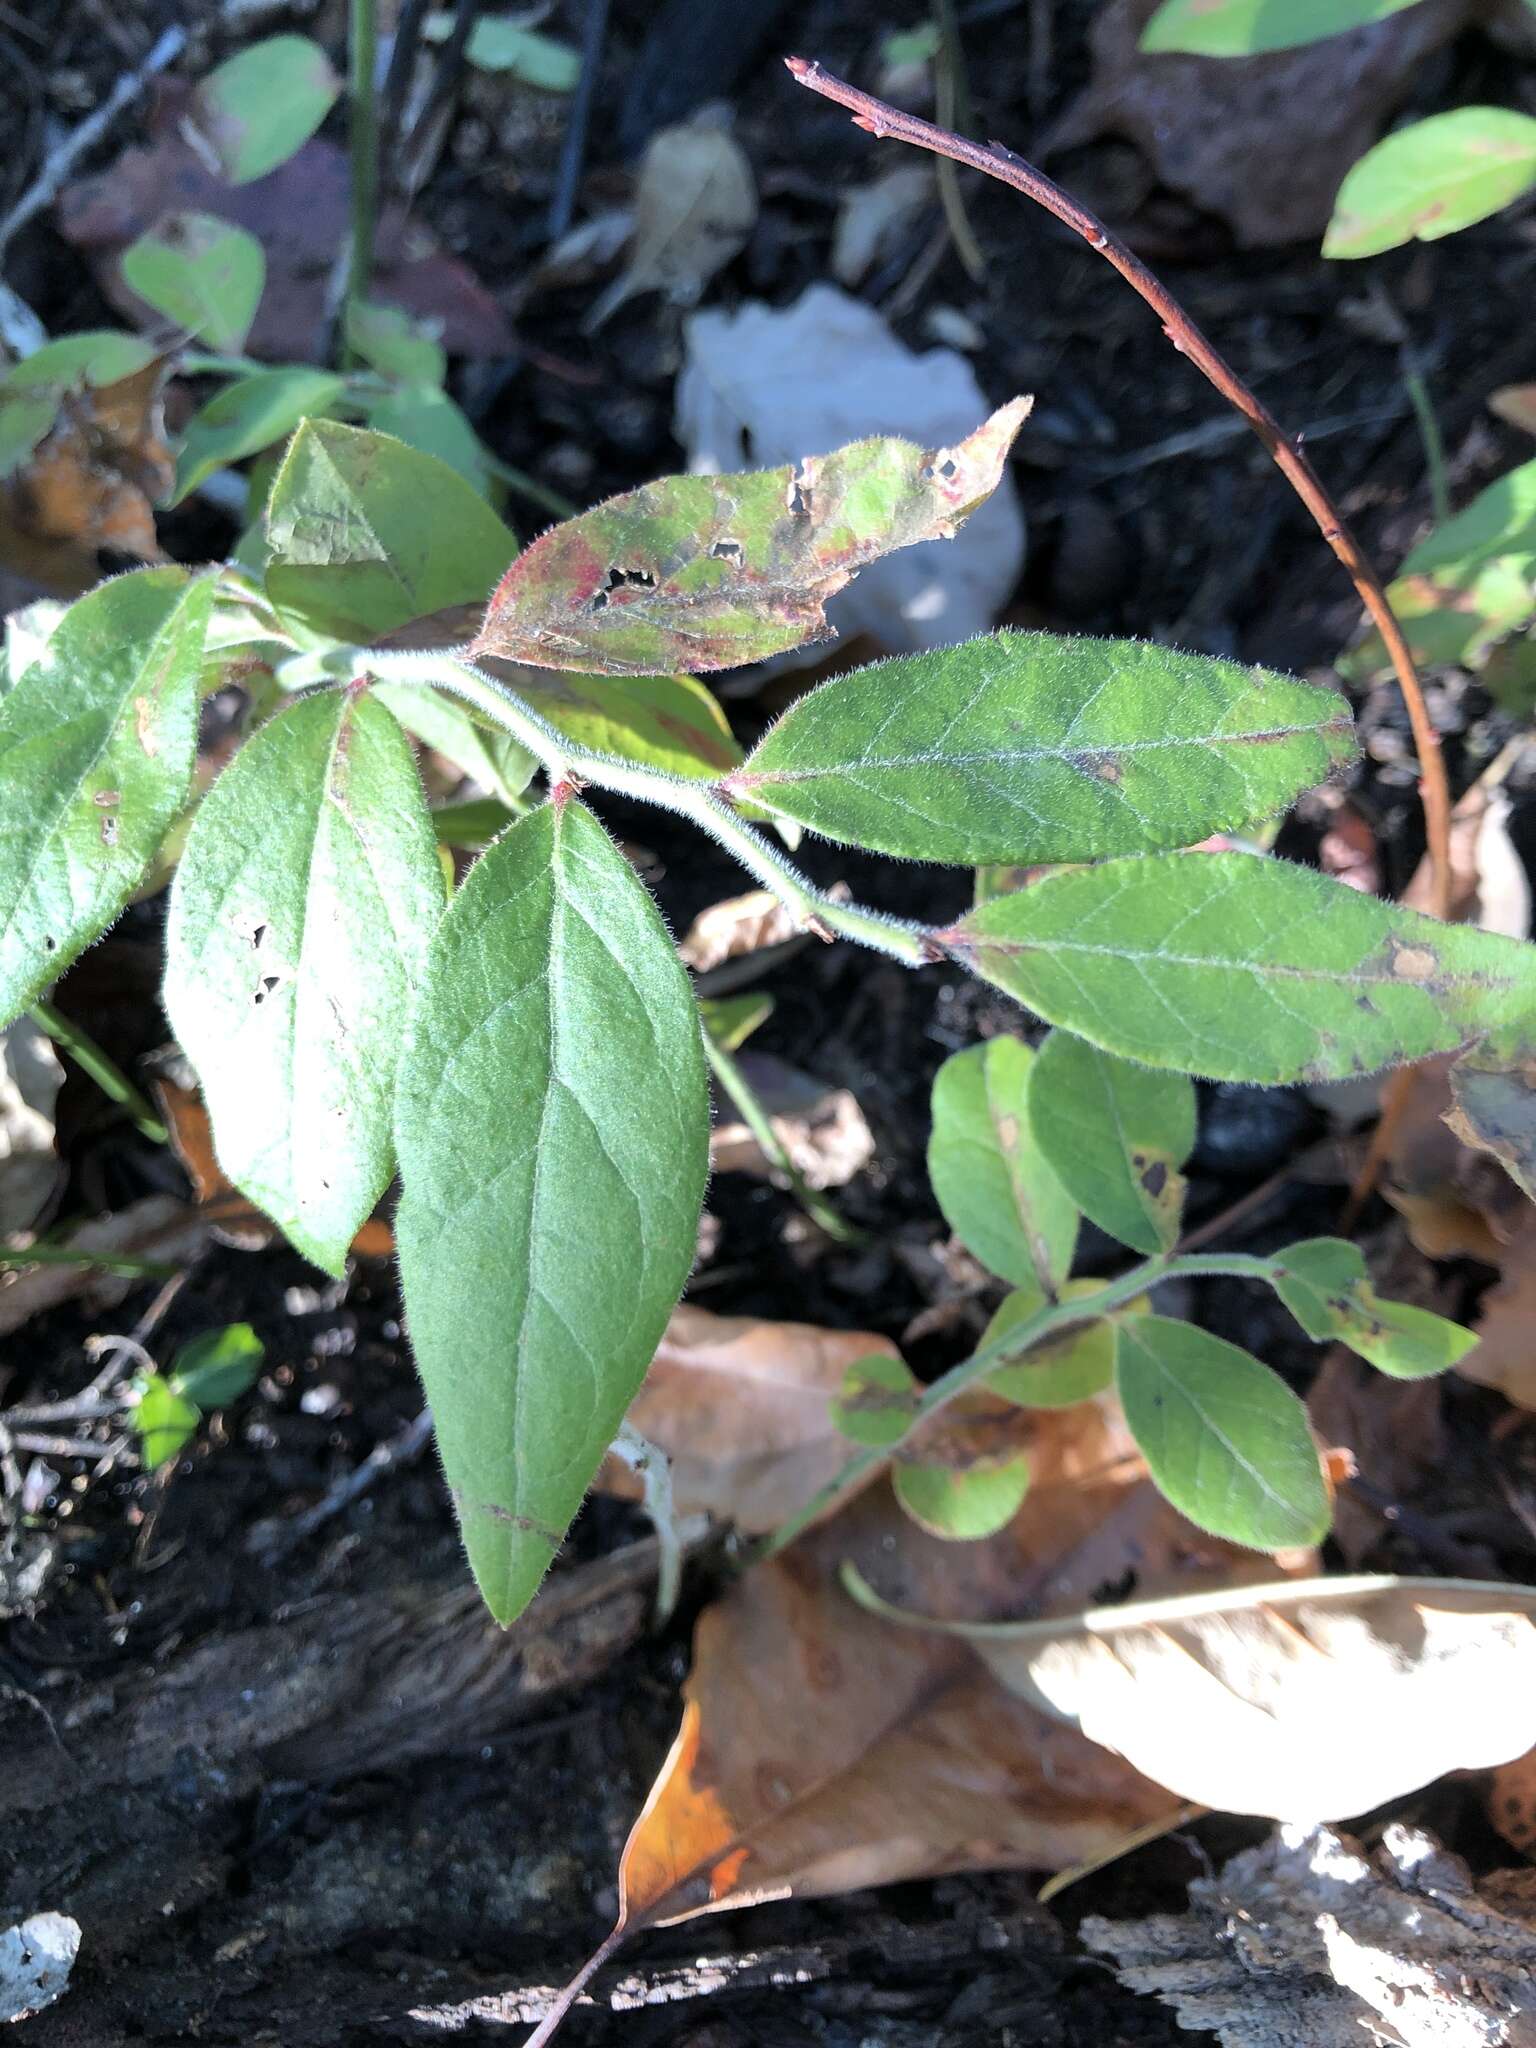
784, 57, 1450, 918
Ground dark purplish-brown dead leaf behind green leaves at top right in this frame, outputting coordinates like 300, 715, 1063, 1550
1036, 0, 1483, 248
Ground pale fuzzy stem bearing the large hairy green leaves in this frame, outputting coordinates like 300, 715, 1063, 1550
364, 647, 932, 967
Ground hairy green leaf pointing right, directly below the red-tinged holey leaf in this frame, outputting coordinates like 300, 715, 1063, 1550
725, 633, 1354, 866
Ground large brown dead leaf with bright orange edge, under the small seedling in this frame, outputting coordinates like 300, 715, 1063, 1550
621, 1403, 1274, 1931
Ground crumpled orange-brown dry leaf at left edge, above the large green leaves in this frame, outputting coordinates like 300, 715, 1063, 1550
0, 356, 176, 598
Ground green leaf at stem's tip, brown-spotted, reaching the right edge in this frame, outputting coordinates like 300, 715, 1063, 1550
938, 854, 1536, 1083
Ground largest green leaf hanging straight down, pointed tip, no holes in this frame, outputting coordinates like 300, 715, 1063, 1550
395, 801, 709, 1622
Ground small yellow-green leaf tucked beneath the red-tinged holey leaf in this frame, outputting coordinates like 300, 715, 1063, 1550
485, 662, 741, 776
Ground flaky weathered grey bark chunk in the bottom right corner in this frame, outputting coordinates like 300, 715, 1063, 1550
1081, 1827, 1536, 2048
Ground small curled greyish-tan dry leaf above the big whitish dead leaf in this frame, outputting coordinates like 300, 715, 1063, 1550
586, 109, 758, 334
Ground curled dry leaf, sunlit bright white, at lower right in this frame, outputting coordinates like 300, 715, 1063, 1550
864, 1577, 1536, 1821
